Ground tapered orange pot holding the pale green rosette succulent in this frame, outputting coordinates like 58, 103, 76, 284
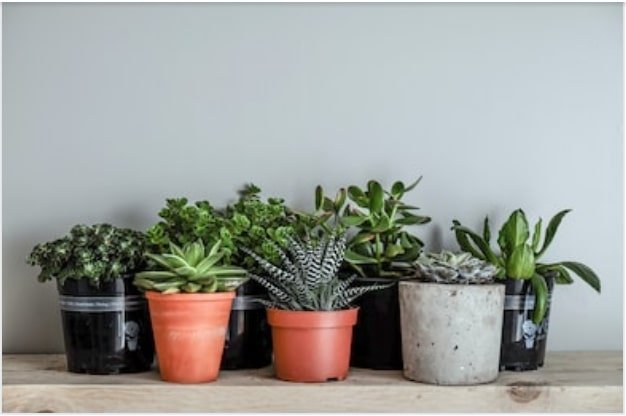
146, 291, 235, 383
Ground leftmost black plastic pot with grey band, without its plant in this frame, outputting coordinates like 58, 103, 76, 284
57, 277, 154, 374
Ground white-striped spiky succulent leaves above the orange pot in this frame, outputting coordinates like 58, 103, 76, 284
242, 233, 389, 311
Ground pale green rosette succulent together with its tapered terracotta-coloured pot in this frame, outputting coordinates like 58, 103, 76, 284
134, 240, 246, 383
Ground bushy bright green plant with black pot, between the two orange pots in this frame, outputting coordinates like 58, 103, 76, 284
148, 184, 293, 370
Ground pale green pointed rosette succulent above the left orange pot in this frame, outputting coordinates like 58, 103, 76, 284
134, 240, 246, 293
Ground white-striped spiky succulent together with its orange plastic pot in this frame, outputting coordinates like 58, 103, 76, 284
241, 234, 386, 382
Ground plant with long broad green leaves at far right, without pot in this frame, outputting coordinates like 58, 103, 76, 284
452, 209, 600, 324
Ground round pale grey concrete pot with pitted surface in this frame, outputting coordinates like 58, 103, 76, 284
400, 281, 505, 385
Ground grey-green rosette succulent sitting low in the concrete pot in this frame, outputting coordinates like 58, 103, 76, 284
416, 250, 498, 284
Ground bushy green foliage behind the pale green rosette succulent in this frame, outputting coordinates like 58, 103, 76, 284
147, 184, 297, 272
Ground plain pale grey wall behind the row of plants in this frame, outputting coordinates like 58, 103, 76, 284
2, 3, 624, 352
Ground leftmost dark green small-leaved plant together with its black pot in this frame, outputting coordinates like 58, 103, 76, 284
27, 224, 154, 374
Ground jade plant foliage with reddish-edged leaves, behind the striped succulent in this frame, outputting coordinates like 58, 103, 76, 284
315, 178, 430, 277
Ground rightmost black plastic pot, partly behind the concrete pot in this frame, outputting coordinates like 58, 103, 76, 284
500, 278, 554, 371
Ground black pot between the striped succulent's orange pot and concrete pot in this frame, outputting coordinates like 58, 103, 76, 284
350, 278, 411, 370
